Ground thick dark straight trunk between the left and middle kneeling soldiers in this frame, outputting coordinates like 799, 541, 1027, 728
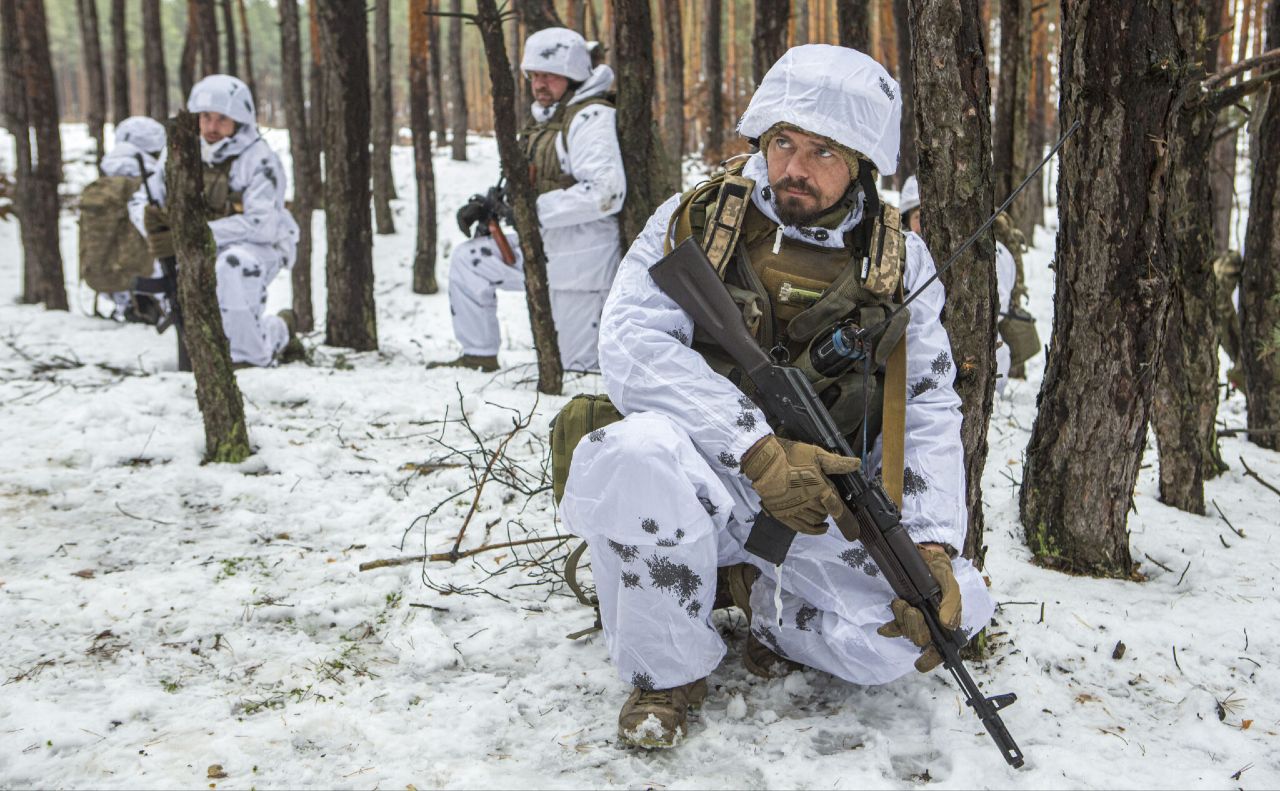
315, 0, 378, 352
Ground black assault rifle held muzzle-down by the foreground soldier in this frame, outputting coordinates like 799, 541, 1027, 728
649, 237, 1023, 768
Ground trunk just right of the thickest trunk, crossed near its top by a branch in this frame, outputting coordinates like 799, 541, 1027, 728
1152, 0, 1226, 513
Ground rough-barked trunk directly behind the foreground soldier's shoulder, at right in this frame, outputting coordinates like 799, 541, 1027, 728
910, 0, 997, 567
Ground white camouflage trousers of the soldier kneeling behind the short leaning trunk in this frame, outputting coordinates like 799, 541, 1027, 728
215, 242, 289, 366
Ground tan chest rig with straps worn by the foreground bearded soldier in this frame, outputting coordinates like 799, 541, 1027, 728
667, 166, 910, 506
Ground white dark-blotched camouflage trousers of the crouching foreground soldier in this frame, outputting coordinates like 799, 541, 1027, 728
561, 412, 995, 689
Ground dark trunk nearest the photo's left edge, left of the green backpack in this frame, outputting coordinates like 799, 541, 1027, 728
15, 0, 67, 310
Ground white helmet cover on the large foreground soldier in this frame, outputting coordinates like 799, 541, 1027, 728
737, 44, 902, 175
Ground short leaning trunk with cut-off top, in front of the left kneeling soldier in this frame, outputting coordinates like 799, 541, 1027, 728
165, 110, 252, 463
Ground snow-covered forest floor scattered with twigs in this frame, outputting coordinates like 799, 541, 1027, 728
0, 127, 1280, 788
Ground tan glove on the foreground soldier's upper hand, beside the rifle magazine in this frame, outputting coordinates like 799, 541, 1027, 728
742, 434, 861, 535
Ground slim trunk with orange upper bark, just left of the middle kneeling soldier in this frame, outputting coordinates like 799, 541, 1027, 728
408, 0, 440, 294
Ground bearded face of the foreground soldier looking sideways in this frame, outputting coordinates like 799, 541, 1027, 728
764, 129, 852, 225
